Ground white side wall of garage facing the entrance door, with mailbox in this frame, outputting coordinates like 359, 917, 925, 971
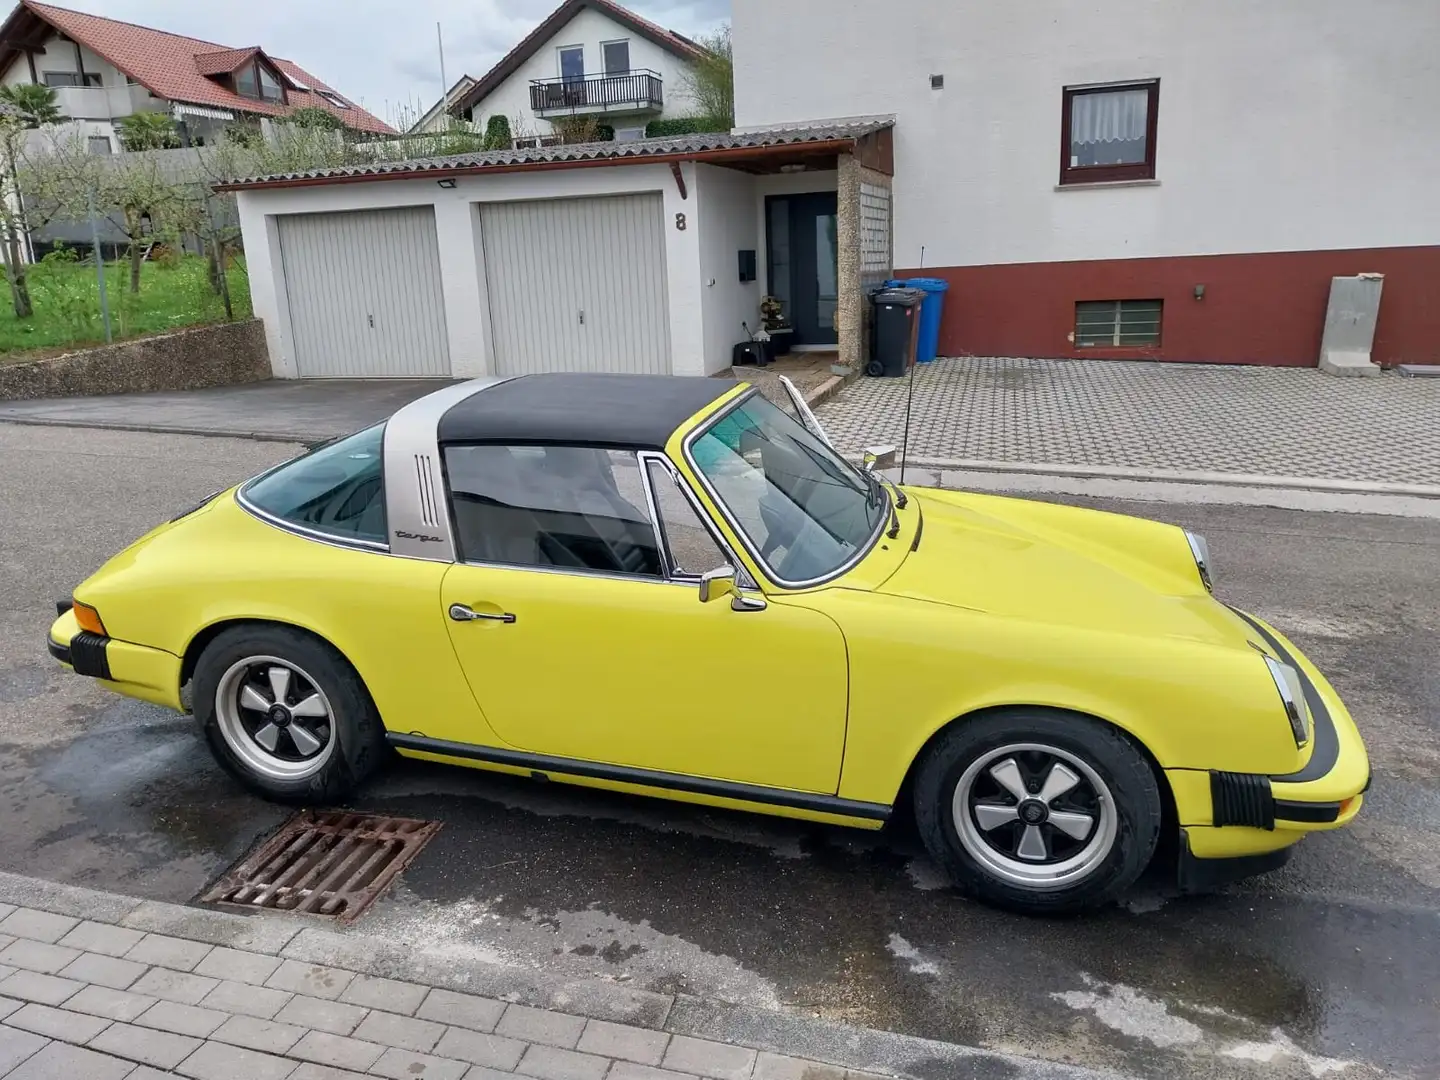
693, 164, 765, 374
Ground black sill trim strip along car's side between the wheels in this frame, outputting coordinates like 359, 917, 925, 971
386, 732, 891, 821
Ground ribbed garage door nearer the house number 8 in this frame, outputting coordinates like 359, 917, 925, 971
480, 193, 670, 374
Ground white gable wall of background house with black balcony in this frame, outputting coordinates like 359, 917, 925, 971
474, 7, 694, 138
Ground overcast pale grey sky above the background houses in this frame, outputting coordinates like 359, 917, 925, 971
78, 0, 730, 122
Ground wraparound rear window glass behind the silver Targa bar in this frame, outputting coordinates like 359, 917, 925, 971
240, 423, 389, 544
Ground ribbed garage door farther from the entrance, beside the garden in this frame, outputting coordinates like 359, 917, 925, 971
278, 206, 451, 379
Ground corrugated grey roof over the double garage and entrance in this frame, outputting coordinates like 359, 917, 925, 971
219, 117, 894, 192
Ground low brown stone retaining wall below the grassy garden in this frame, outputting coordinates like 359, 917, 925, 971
0, 325, 271, 402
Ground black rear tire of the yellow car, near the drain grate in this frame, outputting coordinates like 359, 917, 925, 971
193, 624, 387, 805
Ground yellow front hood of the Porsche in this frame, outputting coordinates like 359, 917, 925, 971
880, 488, 1247, 648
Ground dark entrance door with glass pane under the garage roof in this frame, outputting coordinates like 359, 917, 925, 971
766, 192, 840, 346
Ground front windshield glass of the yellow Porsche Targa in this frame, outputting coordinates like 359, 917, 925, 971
690, 395, 888, 585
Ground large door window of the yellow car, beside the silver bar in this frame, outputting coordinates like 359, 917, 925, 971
445, 445, 662, 577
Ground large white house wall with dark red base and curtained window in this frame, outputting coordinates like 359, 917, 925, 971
733, 0, 1440, 368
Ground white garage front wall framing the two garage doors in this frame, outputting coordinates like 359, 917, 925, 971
238, 164, 708, 379
